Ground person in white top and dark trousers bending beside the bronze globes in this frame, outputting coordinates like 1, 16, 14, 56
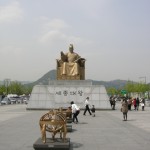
71, 101, 80, 123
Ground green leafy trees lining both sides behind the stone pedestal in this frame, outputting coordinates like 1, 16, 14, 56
0, 81, 150, 96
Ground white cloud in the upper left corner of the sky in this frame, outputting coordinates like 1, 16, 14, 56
0, 1, 23, 23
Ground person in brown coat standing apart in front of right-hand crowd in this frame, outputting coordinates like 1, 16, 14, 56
121, 98, 128, 121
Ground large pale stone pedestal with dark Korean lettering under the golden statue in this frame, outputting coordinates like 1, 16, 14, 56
27, 80, 111, 109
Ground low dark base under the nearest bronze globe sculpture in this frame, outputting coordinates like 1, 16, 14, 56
33, 138, 70, 150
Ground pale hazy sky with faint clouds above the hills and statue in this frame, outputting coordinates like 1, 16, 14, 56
0, 0, 150, 83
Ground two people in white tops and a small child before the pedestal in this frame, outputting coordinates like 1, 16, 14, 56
70, 97, 95, 123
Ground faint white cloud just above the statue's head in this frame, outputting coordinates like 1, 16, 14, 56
39, 17, 92, 45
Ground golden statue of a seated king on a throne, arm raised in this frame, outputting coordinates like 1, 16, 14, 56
57, 44, 85, 80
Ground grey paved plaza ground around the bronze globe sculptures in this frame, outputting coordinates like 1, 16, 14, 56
0, 104, 150, 150
